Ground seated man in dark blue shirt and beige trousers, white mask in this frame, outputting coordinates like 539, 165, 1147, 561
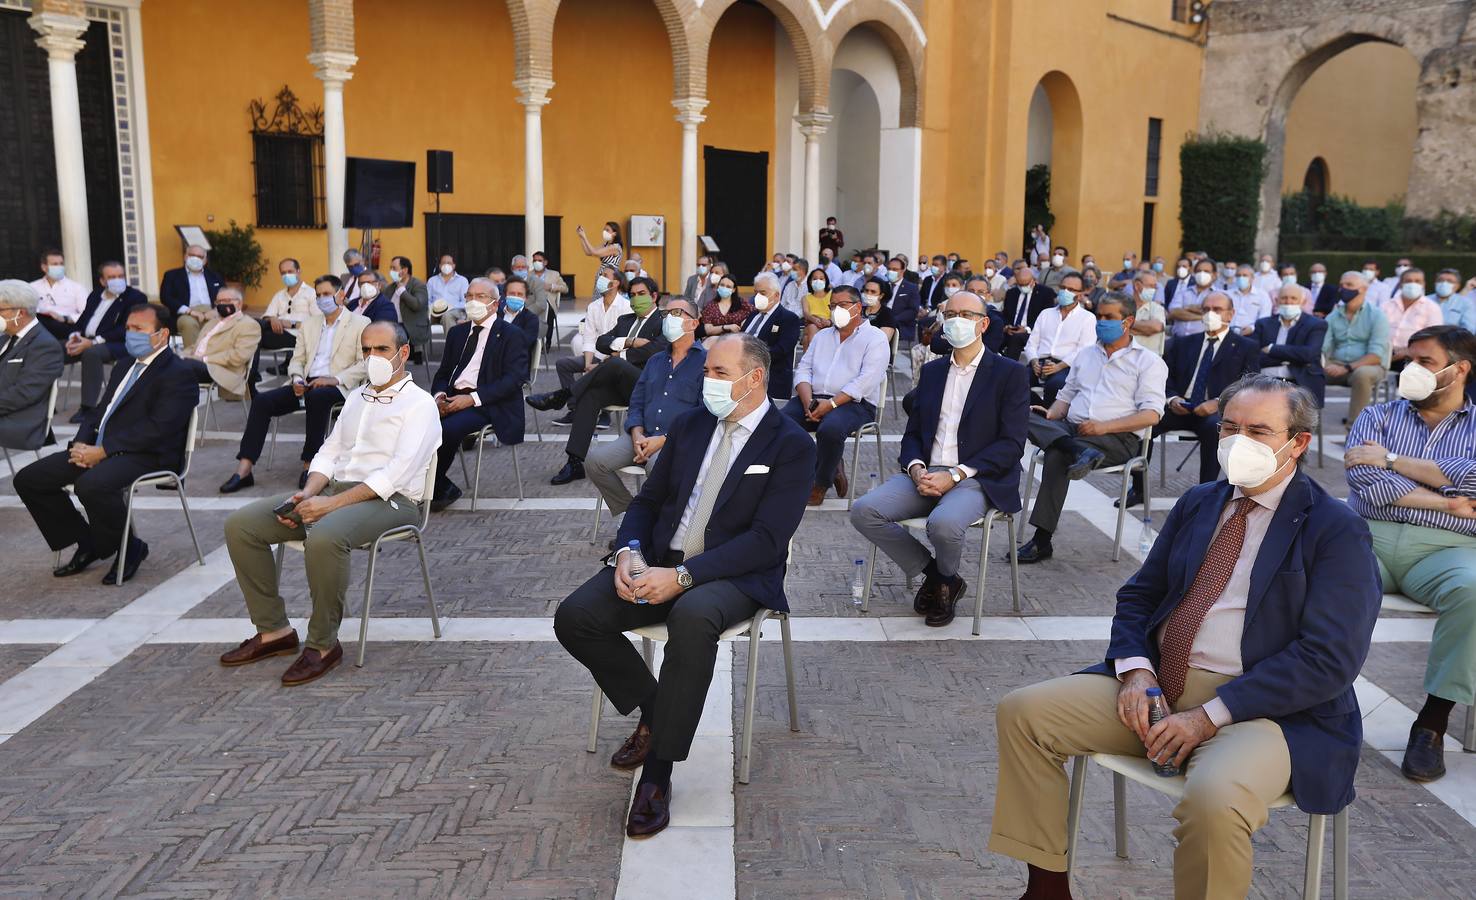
584, 297, 705, 550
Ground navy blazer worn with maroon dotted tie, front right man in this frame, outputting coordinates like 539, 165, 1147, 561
1086, 471, 1383, 814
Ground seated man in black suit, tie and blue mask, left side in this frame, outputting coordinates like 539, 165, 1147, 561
15, 304, 199, 584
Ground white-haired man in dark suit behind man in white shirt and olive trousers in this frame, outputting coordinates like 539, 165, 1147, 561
431, 277, 528, 512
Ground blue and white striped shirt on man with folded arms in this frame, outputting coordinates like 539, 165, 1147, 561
1348, 400, 1476, 537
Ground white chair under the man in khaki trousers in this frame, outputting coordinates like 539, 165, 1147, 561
1066, 752, 1348, 900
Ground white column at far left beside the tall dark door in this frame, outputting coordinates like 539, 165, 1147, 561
30, 12, 94, 285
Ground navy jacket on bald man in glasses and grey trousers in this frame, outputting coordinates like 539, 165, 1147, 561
897, 346, 1030, 513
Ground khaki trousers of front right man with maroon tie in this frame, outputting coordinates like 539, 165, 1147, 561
989, 668, 1292, 900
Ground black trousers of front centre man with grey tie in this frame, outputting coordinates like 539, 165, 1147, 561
554, 567, 759, 763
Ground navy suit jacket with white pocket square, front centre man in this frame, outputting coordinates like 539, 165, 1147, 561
615, 403, 816, 612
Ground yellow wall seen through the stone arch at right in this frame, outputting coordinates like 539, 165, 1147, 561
1281, 44, 1420, 205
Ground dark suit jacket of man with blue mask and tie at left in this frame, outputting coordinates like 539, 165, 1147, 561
74, 347, 199, 472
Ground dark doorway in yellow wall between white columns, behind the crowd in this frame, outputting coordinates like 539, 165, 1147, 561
703, 146, 773, 285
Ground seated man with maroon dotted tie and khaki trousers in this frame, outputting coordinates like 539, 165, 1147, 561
989, 375, 1380, 900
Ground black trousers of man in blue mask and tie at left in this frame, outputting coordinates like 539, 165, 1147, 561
15, 451, 164, 556
